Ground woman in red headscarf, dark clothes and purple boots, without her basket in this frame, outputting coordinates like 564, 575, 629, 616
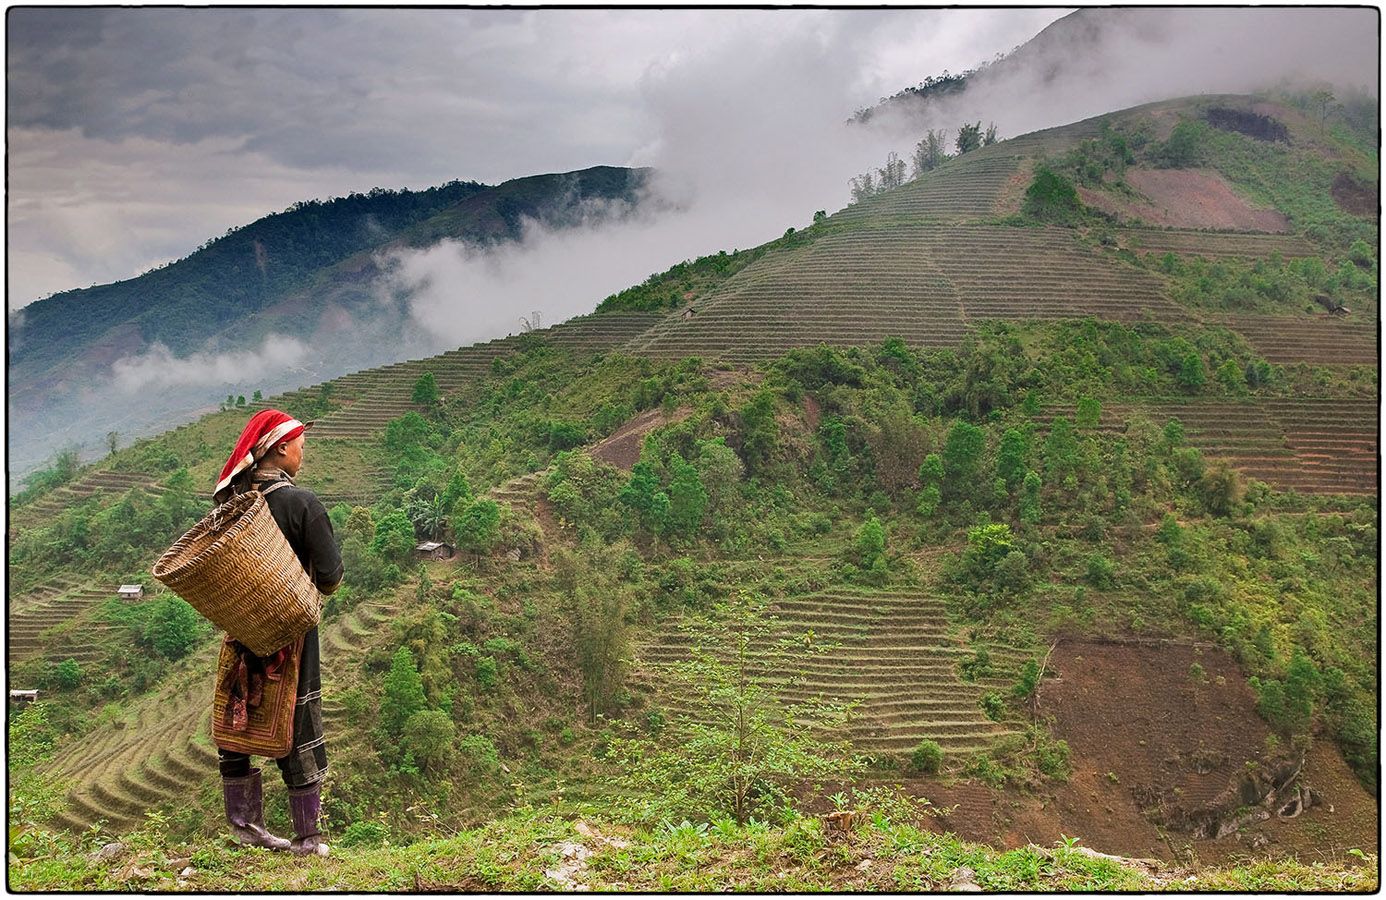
213, 409, 342, 856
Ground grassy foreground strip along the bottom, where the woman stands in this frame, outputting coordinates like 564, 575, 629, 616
8, 810, 1378, 892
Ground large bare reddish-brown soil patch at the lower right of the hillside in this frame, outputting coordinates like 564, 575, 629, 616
864, 641, 1378, 864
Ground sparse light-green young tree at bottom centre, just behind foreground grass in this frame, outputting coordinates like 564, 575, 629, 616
607, 591, 861, 825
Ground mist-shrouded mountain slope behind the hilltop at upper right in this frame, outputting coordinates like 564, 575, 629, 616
873, 7, 1379, 144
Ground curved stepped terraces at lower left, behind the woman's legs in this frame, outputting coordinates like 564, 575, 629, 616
44, 599, 399, 832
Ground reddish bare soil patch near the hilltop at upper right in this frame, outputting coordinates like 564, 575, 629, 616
1078, 168, 1290, 233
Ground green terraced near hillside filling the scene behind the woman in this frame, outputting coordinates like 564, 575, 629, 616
10, 87, 1379, 890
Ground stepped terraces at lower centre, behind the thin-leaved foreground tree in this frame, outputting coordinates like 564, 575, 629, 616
638, 588, 1033, 759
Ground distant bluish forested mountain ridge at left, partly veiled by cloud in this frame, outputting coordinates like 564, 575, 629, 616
8, 166, 649, 471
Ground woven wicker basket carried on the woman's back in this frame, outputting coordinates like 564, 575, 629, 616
152, 491, 322, 656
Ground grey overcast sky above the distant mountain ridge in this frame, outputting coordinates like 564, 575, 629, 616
7, 8, 1067, 308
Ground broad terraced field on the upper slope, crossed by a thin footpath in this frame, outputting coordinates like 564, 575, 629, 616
625, 225, 1188, 362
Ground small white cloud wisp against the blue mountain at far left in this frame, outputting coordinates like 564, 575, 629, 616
111, 336, 310, 395
